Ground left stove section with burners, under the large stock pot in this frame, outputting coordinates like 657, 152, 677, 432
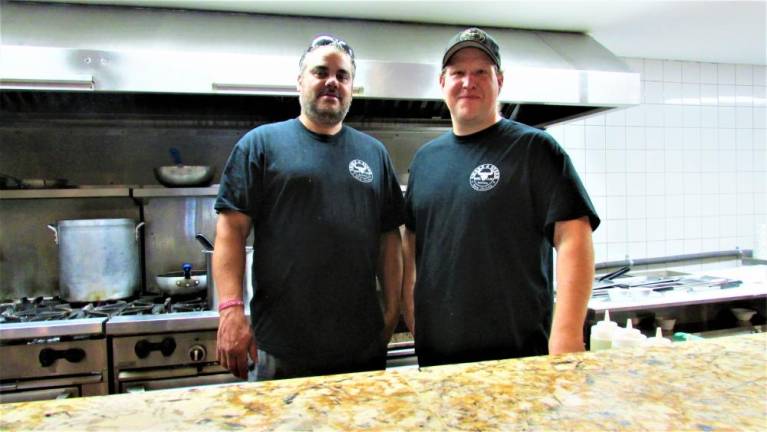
0, 298, 109, 402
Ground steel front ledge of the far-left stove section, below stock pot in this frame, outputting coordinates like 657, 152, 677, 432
0, 318, 107, 341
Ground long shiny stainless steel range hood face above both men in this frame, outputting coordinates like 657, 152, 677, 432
0, 1, 640, 127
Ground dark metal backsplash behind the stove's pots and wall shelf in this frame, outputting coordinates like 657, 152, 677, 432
0, 113, 447, 299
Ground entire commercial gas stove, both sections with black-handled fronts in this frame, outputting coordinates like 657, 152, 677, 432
0, 296, 236, 402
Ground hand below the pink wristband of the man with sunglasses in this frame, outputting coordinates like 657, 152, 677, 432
216, 307, 258, 380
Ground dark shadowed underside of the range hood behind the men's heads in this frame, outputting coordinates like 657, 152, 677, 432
0, 90, 600, 128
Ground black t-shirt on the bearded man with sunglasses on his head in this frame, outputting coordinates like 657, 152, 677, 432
215, 119, 404, 362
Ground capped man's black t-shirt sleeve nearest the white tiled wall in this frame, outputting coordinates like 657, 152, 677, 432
534, 132, 600, 244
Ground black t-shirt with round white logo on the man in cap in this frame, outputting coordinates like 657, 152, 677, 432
405, 120, 599, 366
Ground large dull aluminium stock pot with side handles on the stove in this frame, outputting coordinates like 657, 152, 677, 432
48, 219, 144, 302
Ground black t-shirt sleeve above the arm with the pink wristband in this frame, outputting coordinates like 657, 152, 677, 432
214, 131, 264, 222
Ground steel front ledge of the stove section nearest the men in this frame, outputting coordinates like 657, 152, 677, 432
106, 311, 225, 336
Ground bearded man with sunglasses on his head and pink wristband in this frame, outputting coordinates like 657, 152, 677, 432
213, 36, 403, 380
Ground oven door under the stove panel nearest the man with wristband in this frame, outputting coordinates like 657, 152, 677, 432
117, 365, 242, 393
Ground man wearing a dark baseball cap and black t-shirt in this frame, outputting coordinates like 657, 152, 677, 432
403, 28, 599, 366
